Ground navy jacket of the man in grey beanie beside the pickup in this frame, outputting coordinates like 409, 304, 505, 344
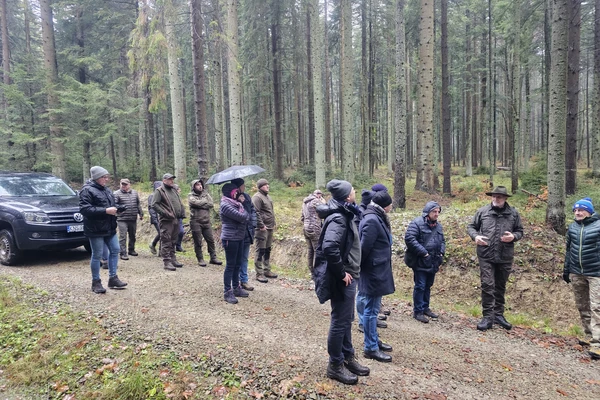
79, 180, 117, 237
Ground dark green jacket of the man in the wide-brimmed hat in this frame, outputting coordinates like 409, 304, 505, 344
467, 202, 523, 264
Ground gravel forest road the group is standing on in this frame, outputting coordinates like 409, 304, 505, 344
0, 250, 600, 400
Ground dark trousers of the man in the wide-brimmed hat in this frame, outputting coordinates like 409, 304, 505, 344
479, 259, 512, 318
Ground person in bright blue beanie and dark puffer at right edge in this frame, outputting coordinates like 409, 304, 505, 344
563, 197, 600, 355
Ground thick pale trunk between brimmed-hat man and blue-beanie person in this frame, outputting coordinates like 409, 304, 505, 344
546, 0, 569, 234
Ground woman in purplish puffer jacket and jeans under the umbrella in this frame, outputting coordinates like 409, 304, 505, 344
220, 183, 250, 304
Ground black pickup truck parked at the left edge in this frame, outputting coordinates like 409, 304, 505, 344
0, 171, 89, 265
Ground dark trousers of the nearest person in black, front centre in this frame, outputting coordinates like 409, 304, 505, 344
327, 279, 356, 364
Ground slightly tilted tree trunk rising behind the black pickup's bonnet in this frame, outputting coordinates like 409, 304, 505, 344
40, 0, 68, 181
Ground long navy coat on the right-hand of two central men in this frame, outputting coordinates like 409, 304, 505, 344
358, 203, 395, 297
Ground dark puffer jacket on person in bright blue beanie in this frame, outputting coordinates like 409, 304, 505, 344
564, 214, 600, 277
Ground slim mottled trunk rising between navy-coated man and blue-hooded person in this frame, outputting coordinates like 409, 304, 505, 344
394, 0, 407, 208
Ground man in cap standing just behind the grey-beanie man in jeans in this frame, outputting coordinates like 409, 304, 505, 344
113, 178, 144, 260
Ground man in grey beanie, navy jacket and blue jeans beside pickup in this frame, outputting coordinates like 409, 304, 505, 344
79, 166, 127, 293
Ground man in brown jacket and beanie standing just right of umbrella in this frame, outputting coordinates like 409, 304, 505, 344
252, 178, 277, 283
